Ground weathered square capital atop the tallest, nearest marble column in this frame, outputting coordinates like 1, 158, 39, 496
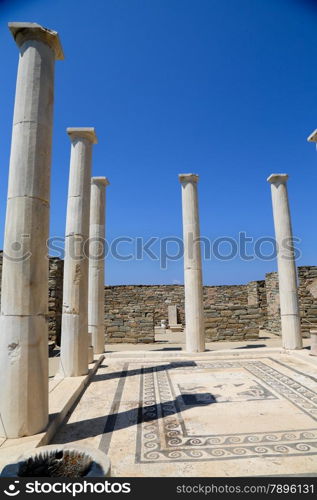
8, 22, 64, 60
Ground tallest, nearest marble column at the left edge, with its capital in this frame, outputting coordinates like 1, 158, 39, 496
0, 23, 63, 438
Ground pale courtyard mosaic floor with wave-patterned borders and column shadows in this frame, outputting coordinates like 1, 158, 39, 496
54, 356, 317, 476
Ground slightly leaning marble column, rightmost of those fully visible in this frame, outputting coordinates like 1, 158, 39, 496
267, 174, 302, 349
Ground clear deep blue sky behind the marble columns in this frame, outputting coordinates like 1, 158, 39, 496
0, 0, 317, 285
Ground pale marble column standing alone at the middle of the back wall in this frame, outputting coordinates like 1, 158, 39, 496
179, 174, 205, 352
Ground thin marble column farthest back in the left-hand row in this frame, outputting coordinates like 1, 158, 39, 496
88, 177, 110, 354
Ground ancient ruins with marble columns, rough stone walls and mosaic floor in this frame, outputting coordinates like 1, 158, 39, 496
0, 22, 317, 477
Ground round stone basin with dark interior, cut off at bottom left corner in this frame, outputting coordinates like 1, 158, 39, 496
0, 444, 110, 478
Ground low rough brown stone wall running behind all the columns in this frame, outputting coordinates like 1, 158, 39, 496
0, 251, 317, 344
